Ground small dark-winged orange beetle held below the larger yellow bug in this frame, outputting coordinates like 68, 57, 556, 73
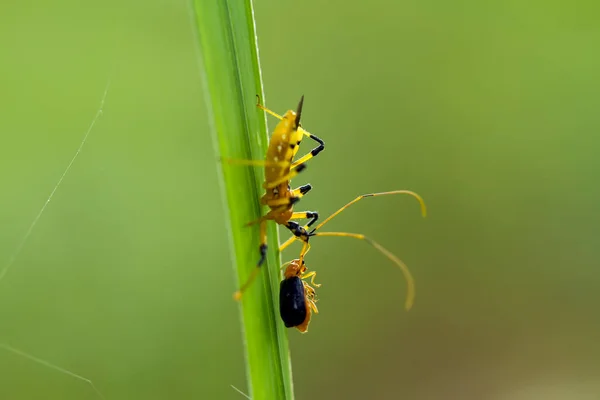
279, 259, 321, 333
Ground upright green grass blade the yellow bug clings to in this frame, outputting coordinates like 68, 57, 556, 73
193, 0, 293, 400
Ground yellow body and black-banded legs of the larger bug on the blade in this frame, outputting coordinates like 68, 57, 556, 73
228, 96, 325, 300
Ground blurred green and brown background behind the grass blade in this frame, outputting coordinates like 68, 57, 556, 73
0, 0, 600, 400
